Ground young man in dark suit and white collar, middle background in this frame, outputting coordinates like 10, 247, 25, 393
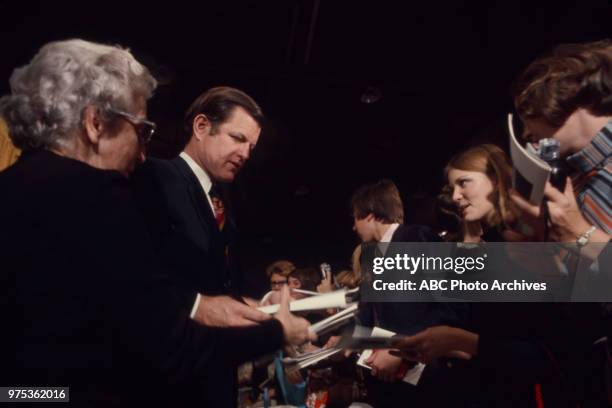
351, 180, 463, 407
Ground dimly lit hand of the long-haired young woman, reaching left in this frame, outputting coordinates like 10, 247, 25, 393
393, 326, 478, 364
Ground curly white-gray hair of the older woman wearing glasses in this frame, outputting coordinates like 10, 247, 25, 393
0, 40, 157, 150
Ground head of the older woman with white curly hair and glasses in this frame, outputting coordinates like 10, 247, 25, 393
0, 40, 157, 175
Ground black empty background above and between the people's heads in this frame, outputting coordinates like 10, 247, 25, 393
0, 0, 612, 294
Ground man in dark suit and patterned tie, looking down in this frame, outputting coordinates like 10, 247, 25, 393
133, 87, 263, 407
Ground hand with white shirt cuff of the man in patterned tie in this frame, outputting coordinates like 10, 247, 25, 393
193, 295, 270, 327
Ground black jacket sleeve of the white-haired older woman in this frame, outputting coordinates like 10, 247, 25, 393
95, 175, 283, 381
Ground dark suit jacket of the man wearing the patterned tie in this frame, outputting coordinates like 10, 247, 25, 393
132, 157, 246, 407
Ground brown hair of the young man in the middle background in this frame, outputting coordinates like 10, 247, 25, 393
351, 179, 404, 224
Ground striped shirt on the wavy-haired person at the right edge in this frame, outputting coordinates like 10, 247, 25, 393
567, 121, 612, 234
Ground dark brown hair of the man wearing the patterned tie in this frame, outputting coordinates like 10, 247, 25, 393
184, 86, 264, 137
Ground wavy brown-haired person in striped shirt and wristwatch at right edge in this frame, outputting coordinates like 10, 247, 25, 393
508, 40, 612, 404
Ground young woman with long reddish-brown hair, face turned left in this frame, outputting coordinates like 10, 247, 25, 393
398, 144, 588, 406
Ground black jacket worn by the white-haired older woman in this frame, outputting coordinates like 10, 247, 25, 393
0, 151, 283, 406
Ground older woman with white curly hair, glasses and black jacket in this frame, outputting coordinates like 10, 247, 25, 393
0, 40, 312, 406
